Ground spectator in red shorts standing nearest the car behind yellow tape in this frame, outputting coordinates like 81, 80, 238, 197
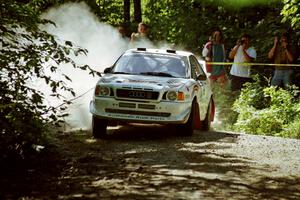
202, 29, 227, 86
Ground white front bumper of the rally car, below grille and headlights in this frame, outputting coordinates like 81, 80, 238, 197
89, 97, 191, 124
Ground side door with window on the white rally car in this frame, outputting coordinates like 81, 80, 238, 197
189, 56, 212, 119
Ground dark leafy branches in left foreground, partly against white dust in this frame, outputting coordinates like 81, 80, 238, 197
0, 0, 95, 160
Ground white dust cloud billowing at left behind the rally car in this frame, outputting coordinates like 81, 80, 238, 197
42, 3, 134, 131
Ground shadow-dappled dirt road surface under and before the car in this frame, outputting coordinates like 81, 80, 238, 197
0, 125, 300, 200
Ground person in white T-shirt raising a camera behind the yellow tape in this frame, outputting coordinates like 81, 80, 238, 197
229, 33, 256, 91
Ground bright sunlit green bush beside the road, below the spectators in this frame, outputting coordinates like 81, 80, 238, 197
233, 78, 300, 137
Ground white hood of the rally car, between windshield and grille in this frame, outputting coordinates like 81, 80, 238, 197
99, 74, 191, 89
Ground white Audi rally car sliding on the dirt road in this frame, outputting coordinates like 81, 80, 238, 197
90, 48, 215, 138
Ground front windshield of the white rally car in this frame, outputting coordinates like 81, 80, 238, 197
112, 53, 188, 78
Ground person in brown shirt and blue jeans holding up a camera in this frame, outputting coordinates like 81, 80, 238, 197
268, 32, 296, 87
